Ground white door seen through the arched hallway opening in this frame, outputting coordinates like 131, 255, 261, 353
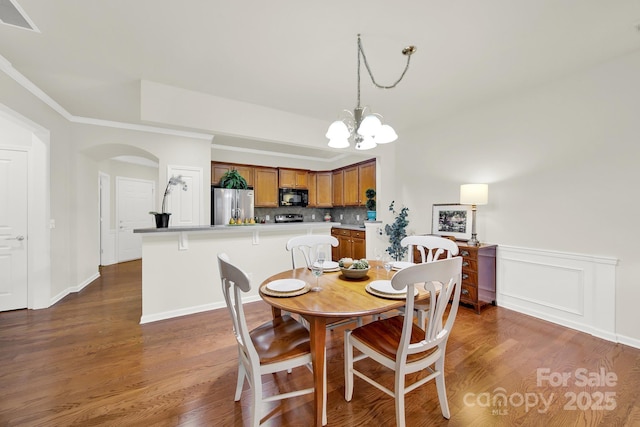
116, 176, 155, 262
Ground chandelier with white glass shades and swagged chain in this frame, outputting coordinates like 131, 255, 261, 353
326, 34, 416, 150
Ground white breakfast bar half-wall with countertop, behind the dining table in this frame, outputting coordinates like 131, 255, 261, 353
134, 222, 340, 323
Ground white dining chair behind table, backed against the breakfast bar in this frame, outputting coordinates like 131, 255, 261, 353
287, 234, 362, 330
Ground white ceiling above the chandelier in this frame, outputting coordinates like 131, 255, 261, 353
0, 0, 640, 157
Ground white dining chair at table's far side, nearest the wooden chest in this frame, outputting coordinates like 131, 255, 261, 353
400, 236, 459, 329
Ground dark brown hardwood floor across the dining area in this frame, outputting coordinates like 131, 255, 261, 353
0, 261, 640, 426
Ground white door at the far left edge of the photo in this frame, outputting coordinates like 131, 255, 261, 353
0, 150, 28, 311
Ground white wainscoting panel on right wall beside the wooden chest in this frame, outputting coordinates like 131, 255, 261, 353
496, 246, 618, 342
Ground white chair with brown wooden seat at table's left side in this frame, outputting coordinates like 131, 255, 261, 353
218, 253, 327, 427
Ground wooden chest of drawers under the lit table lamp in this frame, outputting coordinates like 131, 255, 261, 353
456, 242, 497, 313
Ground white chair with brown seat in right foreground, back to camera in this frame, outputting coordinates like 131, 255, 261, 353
344, 257, 462, 427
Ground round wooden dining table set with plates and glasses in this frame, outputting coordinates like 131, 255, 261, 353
260, 261, 428, 426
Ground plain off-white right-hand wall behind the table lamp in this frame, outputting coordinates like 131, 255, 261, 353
396, 52, 640, 345
